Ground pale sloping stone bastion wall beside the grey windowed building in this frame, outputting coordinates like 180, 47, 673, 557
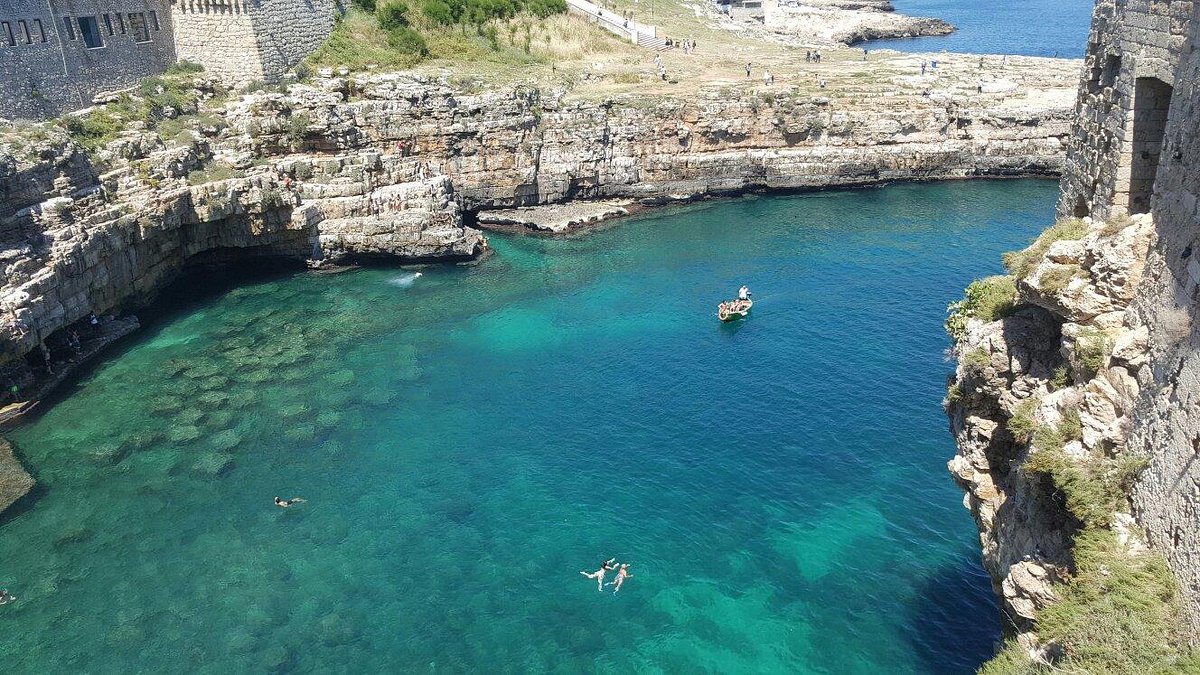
173, 0, 341, 85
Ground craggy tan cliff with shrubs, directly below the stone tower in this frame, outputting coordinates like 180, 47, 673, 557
947, 216, 1153, 644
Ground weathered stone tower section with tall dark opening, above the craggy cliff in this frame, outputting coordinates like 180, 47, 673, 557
1058, 0, 1193, 219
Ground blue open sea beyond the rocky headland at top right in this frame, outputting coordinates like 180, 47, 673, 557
868, 0, 1096, 59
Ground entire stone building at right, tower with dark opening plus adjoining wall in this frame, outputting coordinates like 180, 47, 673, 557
1058, 0, 1200, 635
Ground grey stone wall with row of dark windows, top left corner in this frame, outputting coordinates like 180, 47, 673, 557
0, 0, 175, 118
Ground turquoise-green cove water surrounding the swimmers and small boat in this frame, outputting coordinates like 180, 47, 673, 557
0, 180, 1057, 674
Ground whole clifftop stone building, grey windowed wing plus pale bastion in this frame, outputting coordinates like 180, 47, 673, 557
0, 0, 341, 119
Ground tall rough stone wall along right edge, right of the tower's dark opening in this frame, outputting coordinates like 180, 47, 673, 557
1129, 4, 1200, 635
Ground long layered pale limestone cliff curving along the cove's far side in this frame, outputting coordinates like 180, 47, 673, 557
0, 70, 1068, 386
